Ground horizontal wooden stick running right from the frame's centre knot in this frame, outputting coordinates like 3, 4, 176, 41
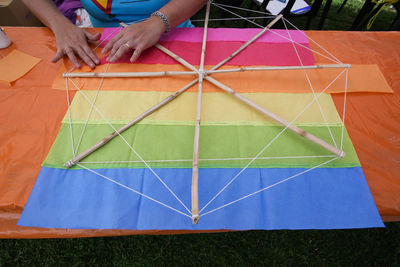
206, 64, 351, 74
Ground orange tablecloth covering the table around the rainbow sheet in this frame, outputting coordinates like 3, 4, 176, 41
0, 27, 400, 238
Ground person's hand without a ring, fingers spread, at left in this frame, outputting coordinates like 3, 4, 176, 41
51, 23, 101, 69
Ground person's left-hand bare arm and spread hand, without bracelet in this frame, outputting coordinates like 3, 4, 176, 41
23, 0, 100, 68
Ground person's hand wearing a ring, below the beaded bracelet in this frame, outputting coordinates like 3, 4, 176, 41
102, 16, 166, 62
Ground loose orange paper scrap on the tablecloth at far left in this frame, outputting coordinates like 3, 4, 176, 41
0, 49, 41, 85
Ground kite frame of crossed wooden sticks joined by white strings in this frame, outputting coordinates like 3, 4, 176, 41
63, 1, 351, 224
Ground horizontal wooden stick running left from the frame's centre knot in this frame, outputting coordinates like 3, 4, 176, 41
63, 71, 198, 78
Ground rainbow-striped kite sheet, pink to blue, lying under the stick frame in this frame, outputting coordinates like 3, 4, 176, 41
18, 11, 383, 230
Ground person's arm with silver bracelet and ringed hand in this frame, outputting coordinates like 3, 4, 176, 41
103, 0, 207, 62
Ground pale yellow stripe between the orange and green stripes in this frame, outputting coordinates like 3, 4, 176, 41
63, 90, 341, 125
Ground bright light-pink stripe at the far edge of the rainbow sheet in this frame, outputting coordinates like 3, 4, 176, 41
102, 28, 308, 44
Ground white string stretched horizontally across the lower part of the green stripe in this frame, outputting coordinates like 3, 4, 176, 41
80, 155, 335, 164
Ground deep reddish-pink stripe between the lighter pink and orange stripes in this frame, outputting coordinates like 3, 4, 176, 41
102, 41, 315, 66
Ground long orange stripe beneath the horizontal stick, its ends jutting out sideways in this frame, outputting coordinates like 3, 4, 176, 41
53, 63, 393, 94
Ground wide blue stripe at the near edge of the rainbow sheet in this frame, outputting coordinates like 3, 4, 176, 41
18, 167, 384, 230
